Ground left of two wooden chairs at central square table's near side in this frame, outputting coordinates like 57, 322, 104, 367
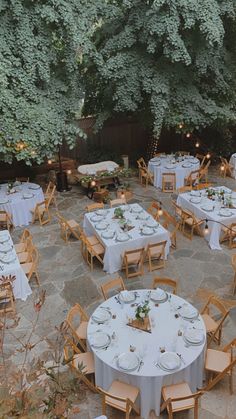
122, 247, 144, 279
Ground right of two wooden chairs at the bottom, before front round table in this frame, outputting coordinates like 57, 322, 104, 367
161, 382, 203, 419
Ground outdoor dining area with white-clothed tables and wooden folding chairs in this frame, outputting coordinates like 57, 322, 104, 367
0, 153, 236, 419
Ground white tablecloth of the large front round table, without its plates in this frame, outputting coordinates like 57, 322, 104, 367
88, 290, 205, 418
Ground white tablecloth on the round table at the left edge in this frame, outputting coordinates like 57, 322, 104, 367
0, 182, 44, 227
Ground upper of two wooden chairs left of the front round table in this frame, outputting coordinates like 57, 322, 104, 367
66, 303, 89, 351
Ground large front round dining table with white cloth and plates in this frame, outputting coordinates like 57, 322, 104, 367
88, 289, 206, 418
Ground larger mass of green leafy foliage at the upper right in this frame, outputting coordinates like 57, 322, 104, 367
81, 0, 236, 136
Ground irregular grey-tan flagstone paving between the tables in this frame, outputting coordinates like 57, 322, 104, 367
5, 170, 236, 419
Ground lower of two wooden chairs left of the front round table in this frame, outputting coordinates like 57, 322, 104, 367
64, 339, 97, 393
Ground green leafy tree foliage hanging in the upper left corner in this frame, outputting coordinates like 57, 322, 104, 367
0, 0, 89, 165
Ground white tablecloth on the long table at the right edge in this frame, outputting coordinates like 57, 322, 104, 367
177, 186, 236, 250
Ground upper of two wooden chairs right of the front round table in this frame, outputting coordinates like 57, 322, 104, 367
201, 295, 229, 345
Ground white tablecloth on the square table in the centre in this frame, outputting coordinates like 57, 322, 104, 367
83, 204, 171, 273
